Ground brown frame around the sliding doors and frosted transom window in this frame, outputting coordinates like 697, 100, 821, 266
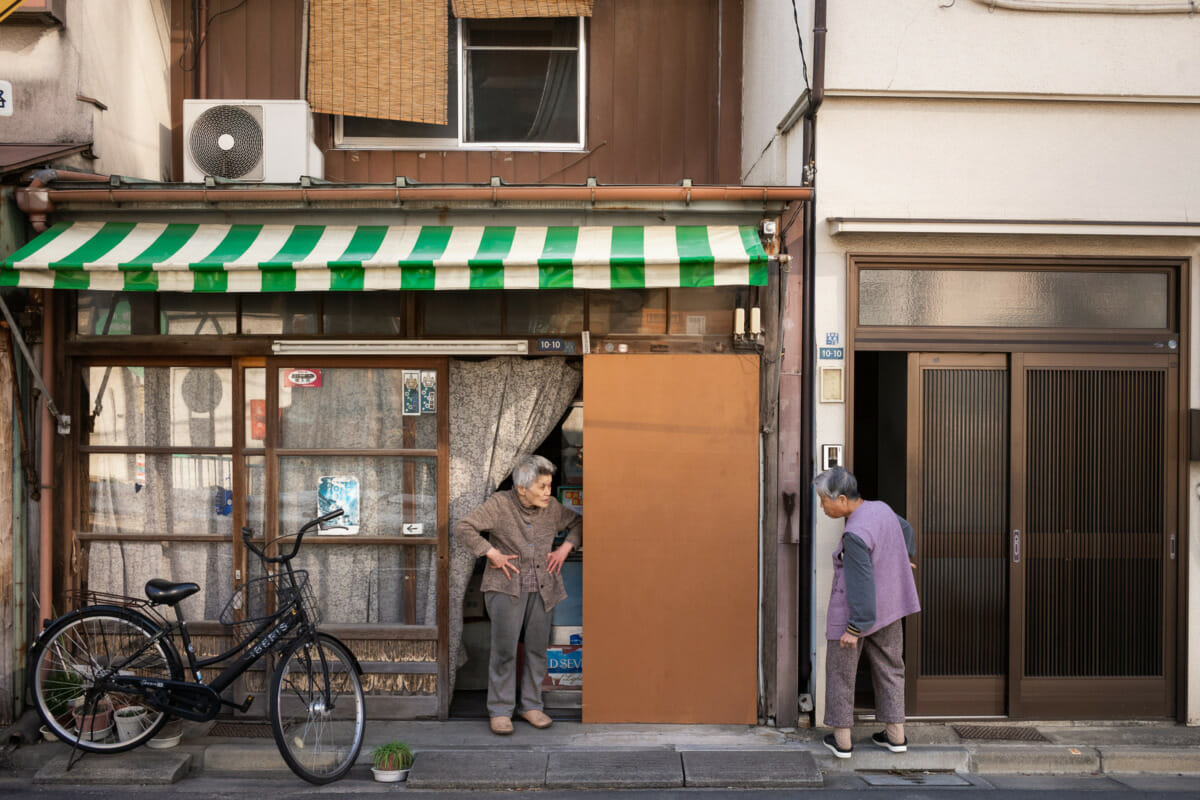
844, 251, 1195, 720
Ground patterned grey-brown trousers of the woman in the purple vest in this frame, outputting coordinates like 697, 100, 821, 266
824, 620, 904, 728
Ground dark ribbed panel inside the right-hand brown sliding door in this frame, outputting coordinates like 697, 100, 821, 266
1024, 368, 1168, 678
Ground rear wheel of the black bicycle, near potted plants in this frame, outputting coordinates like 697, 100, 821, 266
30, 607, 182, 753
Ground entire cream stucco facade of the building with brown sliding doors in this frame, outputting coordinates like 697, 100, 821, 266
743, 0, 1200, 724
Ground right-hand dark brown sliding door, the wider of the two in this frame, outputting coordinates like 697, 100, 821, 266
1009, 354, 1178, 718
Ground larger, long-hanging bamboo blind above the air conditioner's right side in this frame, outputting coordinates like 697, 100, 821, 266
308, 0, 449, 125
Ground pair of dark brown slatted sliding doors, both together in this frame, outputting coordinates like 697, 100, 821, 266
906, 353, 1178, 718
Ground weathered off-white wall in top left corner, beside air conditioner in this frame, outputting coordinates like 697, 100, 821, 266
0, 0, 170, 180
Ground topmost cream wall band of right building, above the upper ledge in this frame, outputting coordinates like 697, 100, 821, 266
830, 0, 1200, 97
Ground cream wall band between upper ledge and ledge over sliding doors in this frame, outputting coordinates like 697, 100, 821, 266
817, 100, 1200, 222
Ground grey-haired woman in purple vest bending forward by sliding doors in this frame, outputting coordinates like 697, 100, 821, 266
812, 467, 920, 758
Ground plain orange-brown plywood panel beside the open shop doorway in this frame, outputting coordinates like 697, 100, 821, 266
583, 355, 758, 724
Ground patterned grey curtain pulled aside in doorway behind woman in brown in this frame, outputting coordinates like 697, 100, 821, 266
448, 356, 583, 692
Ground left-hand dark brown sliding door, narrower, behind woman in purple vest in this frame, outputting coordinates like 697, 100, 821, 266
906, 354, 1009, 716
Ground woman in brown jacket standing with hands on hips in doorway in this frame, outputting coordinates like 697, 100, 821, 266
454, 456, 583, 735
